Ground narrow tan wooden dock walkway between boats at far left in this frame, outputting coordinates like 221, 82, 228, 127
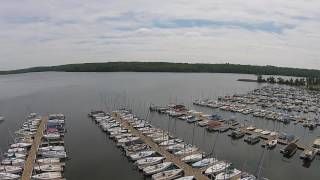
21, 117, 48, 180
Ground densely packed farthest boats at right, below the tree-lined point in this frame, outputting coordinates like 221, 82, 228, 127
218, 86, 320, 113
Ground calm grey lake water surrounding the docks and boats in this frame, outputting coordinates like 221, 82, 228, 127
0, 72, 320, 180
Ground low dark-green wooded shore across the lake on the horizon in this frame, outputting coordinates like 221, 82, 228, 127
0, 62, 320, 77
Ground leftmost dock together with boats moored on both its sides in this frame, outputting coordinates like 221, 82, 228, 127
0, 113, 65, 180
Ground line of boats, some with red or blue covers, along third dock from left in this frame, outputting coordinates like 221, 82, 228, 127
150, 105, 320, 165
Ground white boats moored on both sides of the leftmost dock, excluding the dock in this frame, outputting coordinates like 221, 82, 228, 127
0, 113, 65, 180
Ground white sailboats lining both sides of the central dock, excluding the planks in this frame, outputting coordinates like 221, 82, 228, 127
89, 110, 256, 180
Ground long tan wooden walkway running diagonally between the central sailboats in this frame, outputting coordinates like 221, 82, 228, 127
113, 114, 209, 180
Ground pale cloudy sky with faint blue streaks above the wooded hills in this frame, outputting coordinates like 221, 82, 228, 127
0, 0, 320, 70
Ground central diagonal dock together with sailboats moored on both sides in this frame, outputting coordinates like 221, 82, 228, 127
89, 110, 255, 180
